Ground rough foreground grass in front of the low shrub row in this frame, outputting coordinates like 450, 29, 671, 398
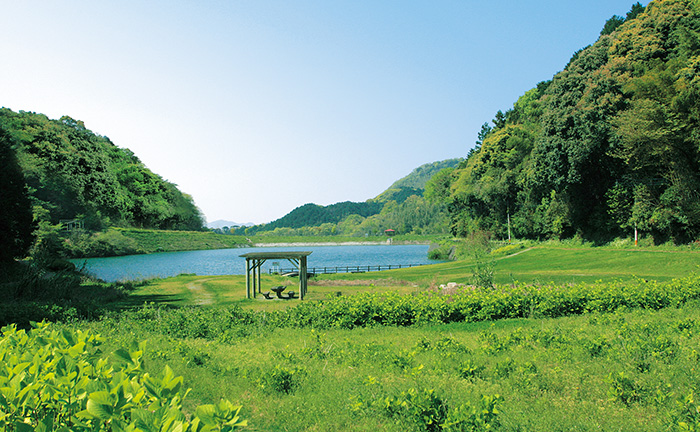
72, 298, 700, 432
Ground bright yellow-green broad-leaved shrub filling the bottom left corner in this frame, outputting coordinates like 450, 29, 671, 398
0, 324, 246, 432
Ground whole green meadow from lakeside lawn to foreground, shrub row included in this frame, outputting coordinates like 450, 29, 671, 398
0, 244, 700, 432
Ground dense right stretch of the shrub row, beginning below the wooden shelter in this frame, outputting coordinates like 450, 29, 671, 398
266, 276, 700, 328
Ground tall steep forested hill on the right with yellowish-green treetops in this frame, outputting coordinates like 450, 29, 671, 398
432, 0, 700, 242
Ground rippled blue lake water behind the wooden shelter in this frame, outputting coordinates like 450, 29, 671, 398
71, 245, 440, 282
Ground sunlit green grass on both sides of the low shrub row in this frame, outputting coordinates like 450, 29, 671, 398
50, 245, 700, 432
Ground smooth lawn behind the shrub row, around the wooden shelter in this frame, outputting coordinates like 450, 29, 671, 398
129, 246, 700, 310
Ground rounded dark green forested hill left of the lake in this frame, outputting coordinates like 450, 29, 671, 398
0, 108, 204, 230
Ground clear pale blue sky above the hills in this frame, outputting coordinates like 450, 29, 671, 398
0, 0, 646, 223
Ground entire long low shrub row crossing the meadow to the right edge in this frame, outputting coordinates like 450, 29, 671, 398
100, 276, 700, 341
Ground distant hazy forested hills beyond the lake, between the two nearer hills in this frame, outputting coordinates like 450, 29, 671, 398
236, 159, 462, 235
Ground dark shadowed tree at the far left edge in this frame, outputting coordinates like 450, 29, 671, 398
0, 128, 35, 263
